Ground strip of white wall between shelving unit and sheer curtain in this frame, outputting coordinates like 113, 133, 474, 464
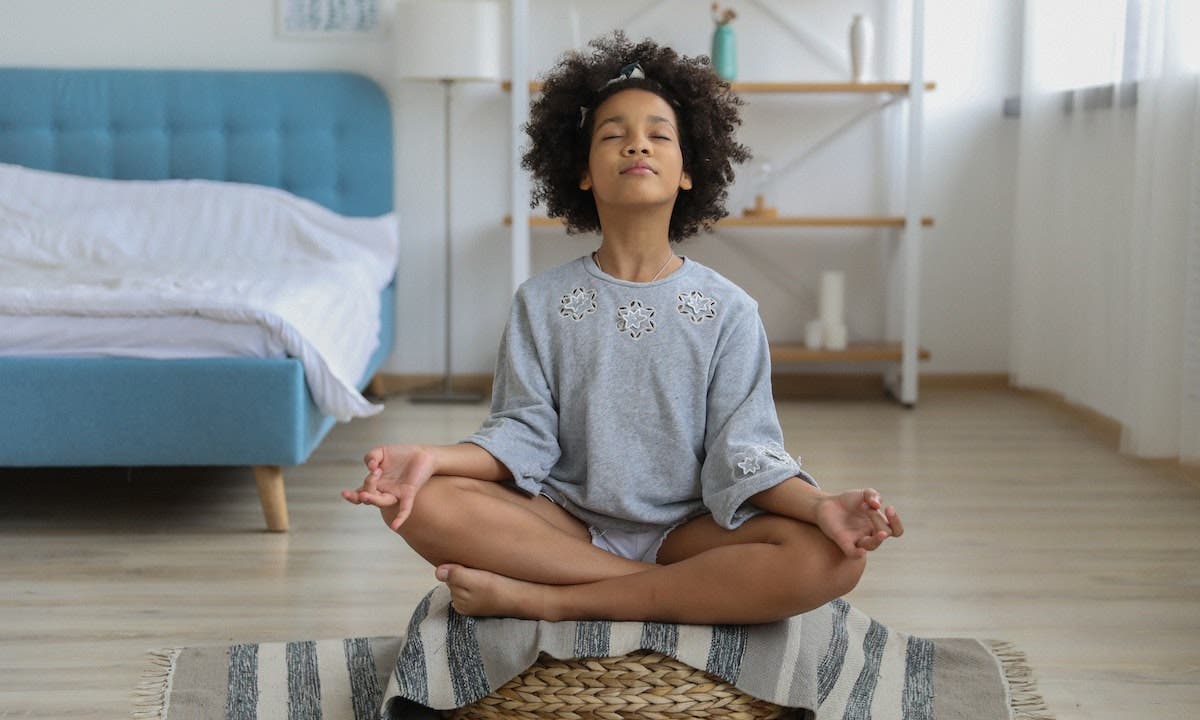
922, 0, 1022, 372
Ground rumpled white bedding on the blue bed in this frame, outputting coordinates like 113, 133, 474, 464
0, 163, 398, 421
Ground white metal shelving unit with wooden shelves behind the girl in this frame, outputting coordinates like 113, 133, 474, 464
506, 0, 934, 407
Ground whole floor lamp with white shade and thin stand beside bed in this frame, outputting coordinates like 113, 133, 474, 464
395, 0, 500, 402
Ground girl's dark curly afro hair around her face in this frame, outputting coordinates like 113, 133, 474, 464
521, 31, 750, 242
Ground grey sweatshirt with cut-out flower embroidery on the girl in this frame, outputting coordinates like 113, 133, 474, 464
466, 257, 816, 530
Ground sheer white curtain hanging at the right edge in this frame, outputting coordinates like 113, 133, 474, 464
1010, 0, 1200, 462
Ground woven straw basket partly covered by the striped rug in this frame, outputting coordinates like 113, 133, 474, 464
450, 650, 793, 720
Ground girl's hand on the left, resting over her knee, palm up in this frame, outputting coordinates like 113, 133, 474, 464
342, 445, 434, 530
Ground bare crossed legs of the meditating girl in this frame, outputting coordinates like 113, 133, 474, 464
400, 478, 865, 624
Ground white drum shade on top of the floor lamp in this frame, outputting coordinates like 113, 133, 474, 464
396, 0, 500, 80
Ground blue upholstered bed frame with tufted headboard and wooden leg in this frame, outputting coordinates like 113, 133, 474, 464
0, 68, 395, 530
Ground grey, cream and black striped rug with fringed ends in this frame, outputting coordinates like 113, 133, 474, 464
134, 586, 1050, 720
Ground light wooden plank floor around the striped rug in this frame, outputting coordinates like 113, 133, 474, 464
0, 390, 1200, 720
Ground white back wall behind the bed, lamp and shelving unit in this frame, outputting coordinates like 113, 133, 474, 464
0, 0, 1019, 373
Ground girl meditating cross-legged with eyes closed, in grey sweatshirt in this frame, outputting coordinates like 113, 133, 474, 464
342, 34, 904, 624
